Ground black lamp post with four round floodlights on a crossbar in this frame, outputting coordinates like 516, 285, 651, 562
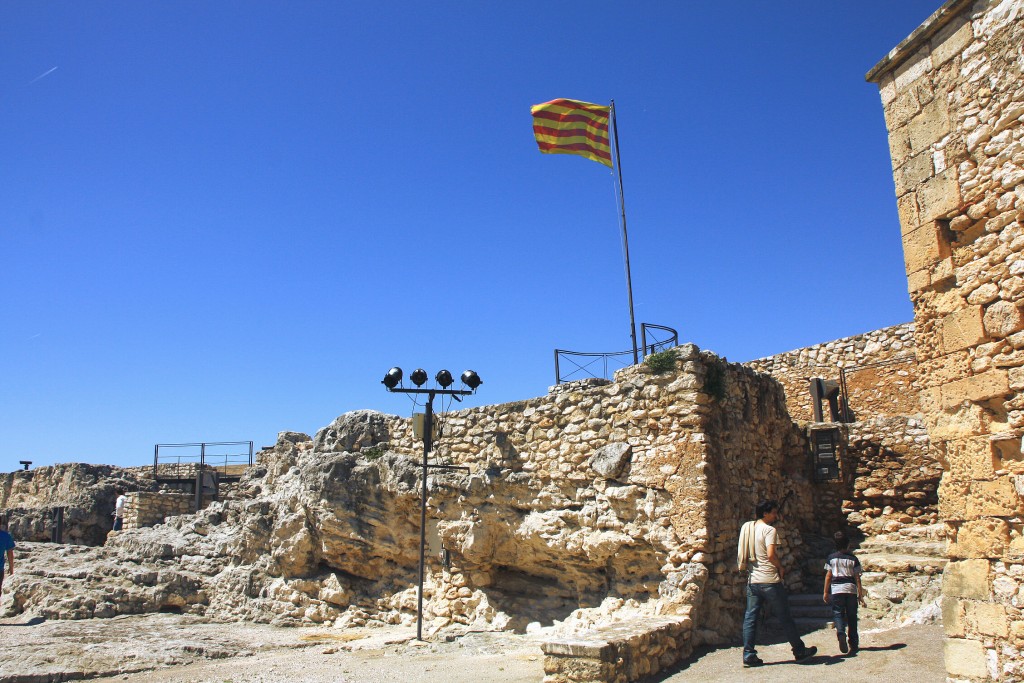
381, 368, 483, 640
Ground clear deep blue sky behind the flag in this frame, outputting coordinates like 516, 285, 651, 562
0, 0, 940, 471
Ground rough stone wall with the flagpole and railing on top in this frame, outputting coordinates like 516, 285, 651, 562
393, 345, 815, 642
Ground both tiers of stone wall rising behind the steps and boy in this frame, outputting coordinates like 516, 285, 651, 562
745, 323, 941, 538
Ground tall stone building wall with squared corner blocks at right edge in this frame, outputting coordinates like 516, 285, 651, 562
868, 0, 1024, 680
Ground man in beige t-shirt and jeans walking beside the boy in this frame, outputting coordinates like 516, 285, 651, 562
740, 501, 818, 667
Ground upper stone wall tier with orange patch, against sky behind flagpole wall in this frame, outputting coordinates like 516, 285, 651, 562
745, 323, 921, 422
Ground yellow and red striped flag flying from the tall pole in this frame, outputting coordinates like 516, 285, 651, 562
529, 99, 611, 167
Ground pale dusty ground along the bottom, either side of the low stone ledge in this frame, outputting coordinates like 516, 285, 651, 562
0, 614, 945, 683
